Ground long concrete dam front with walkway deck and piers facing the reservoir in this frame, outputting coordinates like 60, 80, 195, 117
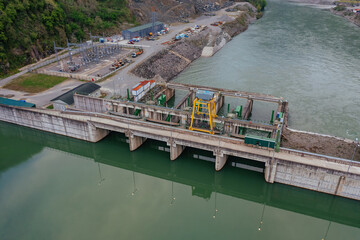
0, 105, 360, 200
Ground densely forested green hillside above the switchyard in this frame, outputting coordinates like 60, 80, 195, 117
0, 0, 136, 76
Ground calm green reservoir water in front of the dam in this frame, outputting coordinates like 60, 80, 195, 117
0, 123, 360, 240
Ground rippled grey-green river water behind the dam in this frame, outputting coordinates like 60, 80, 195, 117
175, 1, 360, 139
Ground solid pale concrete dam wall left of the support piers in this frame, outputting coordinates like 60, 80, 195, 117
0, 105, 109, 142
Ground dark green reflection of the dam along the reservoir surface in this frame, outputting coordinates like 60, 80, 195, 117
0, 123, 360, 232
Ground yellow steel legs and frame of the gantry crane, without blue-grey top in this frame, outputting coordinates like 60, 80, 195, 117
189, 98, 217, 134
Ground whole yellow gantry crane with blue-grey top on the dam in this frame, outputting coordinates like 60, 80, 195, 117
189, 90, 217, 134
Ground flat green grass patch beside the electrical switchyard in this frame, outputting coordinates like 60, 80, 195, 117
4, 73, 67, 93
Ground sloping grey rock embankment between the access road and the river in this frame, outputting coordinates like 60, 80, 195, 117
131, 9, 255, 81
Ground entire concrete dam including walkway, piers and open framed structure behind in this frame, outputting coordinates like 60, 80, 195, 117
0, 83, 360, 200
